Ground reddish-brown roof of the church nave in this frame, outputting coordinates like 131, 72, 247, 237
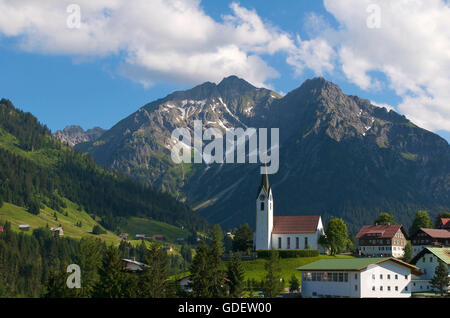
272, 215, 320, 234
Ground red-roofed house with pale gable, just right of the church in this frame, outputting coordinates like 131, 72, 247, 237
356, 224, 407, 258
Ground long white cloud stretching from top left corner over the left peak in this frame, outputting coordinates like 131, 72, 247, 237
0, 0, 294, 86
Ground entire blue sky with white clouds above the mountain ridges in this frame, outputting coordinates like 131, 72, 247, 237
0, 0, 450, 140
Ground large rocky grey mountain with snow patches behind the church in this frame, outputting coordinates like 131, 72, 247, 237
76, 76, 450, 231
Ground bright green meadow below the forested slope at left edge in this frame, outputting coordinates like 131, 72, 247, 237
0, 201, 120, 244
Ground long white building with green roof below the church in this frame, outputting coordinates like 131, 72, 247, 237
297, 257, 420, 298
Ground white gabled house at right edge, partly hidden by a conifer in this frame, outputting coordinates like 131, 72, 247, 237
411, 247, 450, 292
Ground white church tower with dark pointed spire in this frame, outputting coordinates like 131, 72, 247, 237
255, 169, 273, 250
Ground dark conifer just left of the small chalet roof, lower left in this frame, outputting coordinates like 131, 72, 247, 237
94, 246, 125, 298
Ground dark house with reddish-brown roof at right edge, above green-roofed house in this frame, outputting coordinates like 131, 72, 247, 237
411, 228, 450, 257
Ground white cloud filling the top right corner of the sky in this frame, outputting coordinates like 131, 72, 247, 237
321, 0, 450, 131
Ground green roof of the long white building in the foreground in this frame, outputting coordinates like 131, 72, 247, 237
297, 257, 420, 275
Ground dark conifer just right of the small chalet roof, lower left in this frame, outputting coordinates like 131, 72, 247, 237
139, 244, 169, 298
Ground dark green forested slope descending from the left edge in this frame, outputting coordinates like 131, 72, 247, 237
0, 99, 209, 236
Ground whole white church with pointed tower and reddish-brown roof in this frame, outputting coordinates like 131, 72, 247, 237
253, 170, 325, 253
